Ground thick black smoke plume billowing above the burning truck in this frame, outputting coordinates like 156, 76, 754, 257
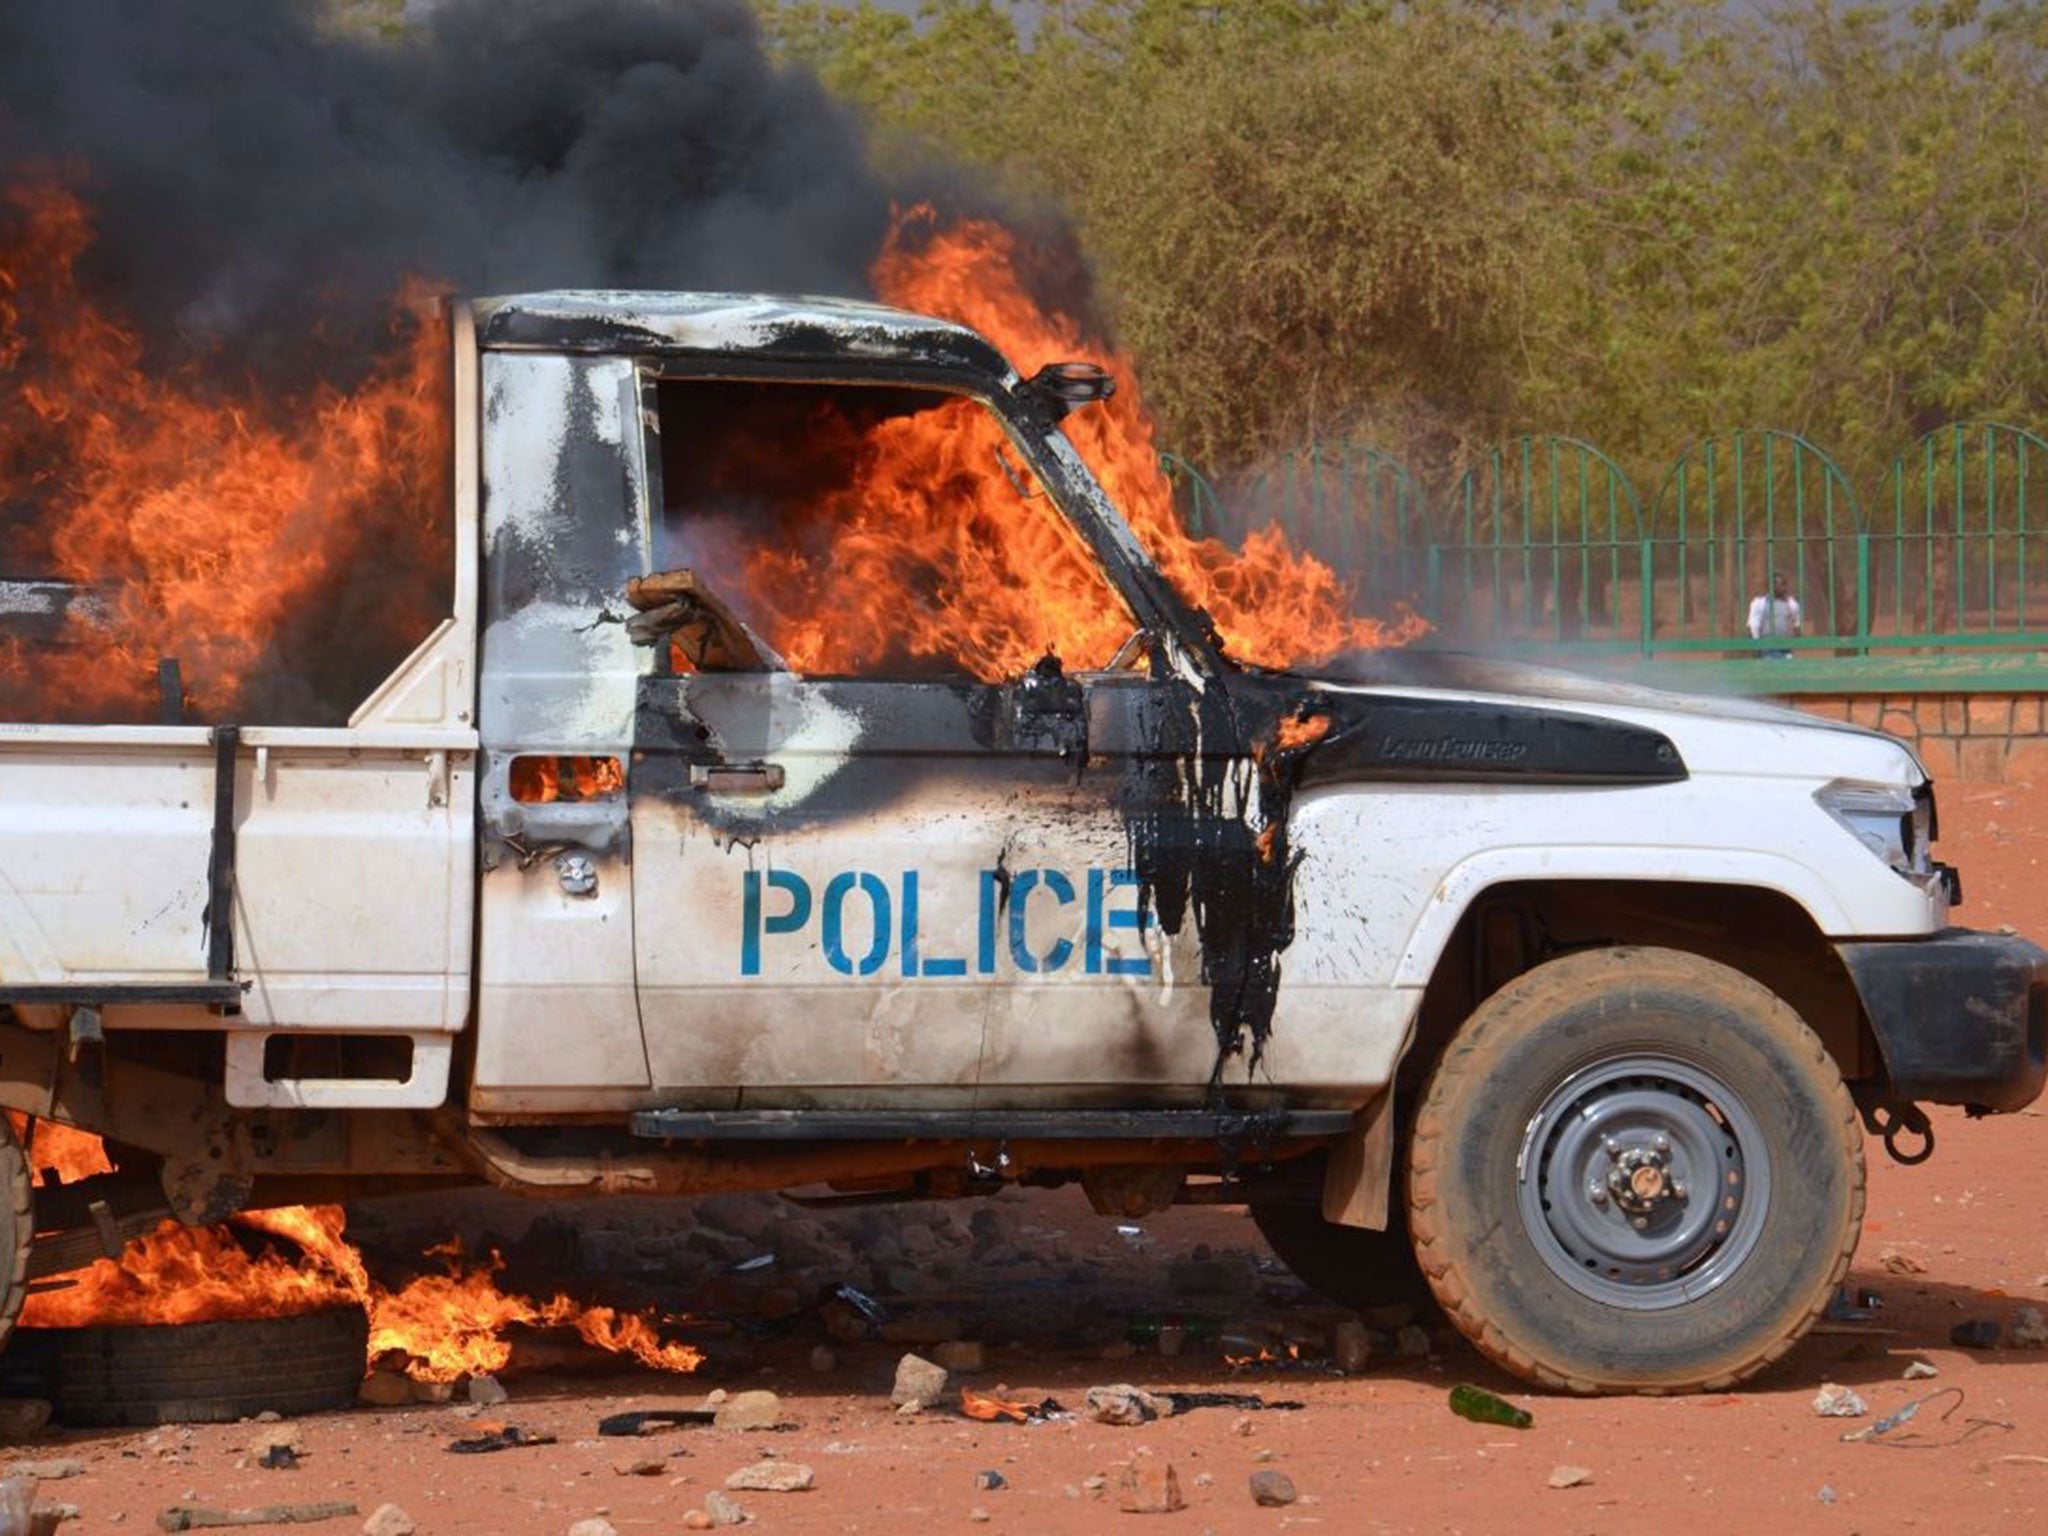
0, 0, 889, 381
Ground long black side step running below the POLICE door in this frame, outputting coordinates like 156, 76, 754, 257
633, 1110, 1354, 1141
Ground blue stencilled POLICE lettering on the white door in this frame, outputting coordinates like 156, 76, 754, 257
739, 868, 1153, 979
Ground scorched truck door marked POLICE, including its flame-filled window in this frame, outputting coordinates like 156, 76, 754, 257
629, 381, 1212, 1108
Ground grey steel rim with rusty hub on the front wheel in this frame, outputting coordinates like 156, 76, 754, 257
1516, 1053, 1772, 1311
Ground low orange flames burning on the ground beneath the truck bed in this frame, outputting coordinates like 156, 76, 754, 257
20, 1120, 702, 1380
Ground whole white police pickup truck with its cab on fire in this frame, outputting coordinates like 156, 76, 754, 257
0, 293, 2048, 1391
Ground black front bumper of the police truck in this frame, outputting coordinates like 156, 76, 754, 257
1835, 928, 2048, 1112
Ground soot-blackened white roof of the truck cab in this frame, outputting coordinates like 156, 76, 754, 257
475, 289, 1010, 379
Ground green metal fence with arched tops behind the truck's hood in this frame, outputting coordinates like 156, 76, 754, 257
1163, 422, 2048, 692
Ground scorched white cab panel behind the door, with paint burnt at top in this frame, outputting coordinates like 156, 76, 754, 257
473, 352, 647, 1104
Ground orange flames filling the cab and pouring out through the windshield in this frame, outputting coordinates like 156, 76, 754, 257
745, 207, 1425, 682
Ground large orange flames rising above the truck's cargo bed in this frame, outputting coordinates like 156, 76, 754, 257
0, 180, 449, 719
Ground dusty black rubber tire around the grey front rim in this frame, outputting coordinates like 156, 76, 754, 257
1407, 948, 1864, 1393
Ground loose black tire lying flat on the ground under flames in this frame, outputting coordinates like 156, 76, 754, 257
23, 1307, 369, 1427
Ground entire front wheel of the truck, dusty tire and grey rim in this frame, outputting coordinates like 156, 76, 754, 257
1407, 948, 1864, 1393
